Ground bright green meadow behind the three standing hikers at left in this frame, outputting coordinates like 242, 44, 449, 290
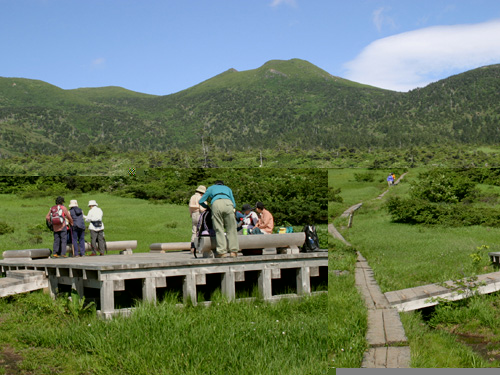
0, 193, 191, 252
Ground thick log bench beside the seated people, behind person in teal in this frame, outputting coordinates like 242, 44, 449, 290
195, 232, 306, 258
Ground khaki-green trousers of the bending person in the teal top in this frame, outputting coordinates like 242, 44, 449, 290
212, 199, 239, 254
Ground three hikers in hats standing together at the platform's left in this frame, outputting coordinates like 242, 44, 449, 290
45, 196, 106, 258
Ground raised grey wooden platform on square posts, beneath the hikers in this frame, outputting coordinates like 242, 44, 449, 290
0, 251, 328, 317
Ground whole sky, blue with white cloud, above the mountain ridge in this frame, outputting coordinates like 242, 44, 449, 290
0, 0, 500, 95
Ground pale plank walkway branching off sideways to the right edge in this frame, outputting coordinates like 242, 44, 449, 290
385, 272, 500, 311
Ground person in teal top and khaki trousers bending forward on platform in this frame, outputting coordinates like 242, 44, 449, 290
199, 180, 239, 258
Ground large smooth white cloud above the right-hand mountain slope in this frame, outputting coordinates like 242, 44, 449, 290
345, 20, 500, 91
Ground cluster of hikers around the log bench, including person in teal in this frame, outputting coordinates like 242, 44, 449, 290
189, 180, 274, 258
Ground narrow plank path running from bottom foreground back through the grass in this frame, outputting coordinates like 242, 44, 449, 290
328, 224, 410, 368
